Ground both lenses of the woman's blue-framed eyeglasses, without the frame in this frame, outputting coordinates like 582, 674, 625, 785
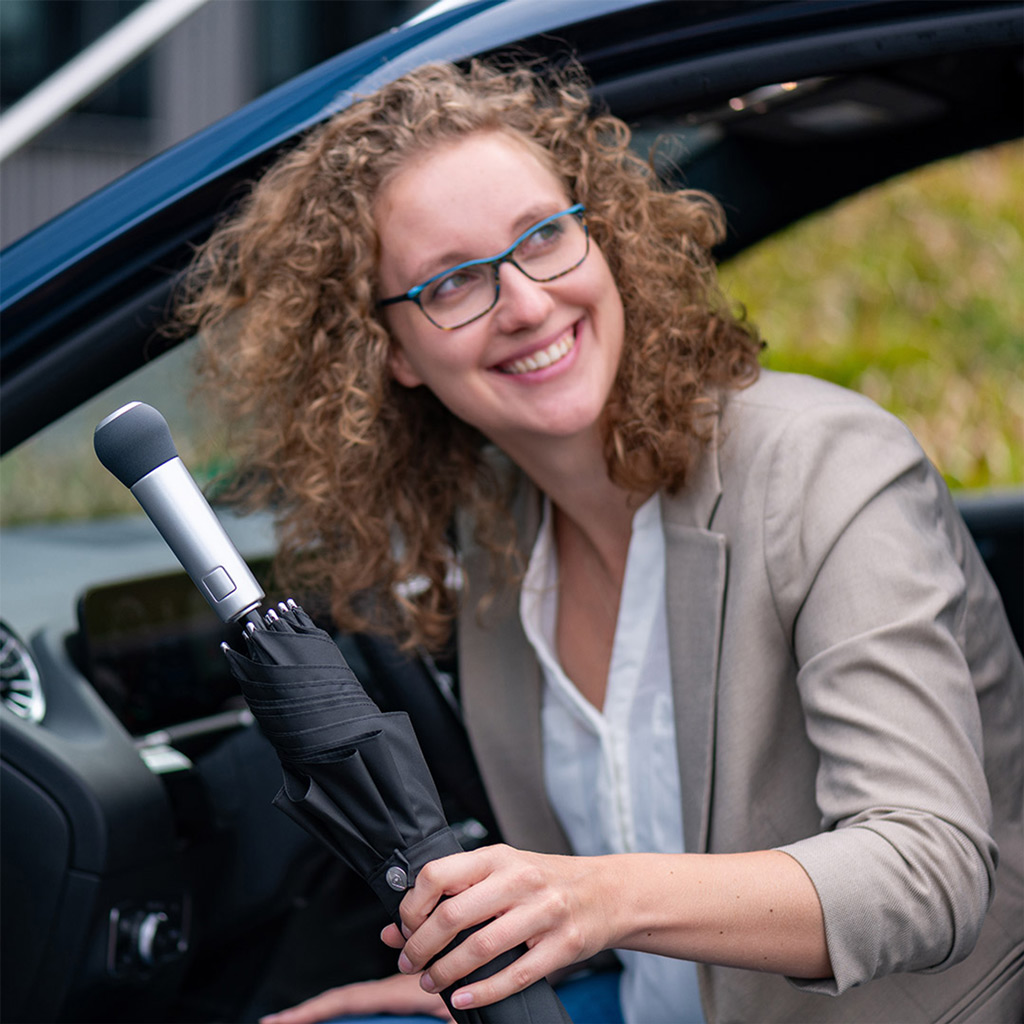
420, 213, 588, 328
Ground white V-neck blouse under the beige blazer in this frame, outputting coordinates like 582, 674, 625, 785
519, 495, 703, 1024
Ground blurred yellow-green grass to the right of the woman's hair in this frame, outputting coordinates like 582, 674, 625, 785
721, 141, 1024, 488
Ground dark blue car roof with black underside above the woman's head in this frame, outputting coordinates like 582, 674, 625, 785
0, 0, 1024, 451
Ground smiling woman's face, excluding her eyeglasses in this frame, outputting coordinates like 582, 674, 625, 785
375, 132, 624, 458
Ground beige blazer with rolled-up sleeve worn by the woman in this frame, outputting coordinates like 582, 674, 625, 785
459, 372, 1024, 1024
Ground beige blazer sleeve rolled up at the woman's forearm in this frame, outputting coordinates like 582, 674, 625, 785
763, 400, 997, 994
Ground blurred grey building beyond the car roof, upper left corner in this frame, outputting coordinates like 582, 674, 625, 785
0, 0, 428, 247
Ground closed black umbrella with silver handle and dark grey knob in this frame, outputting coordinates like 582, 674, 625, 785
94, 401, 571, 1024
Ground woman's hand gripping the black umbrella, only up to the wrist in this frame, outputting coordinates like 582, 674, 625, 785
381, 845, 613, 1010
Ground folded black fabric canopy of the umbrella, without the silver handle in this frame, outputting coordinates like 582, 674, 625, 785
224, 601, 571, 1024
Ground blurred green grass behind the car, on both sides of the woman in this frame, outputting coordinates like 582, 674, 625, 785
0, 141, 1024, 526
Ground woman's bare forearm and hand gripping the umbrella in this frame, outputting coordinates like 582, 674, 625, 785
381, 846, 831, 1010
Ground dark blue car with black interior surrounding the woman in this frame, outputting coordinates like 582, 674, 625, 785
0, 0, 1024, 1022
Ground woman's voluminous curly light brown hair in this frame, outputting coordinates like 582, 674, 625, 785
175, 61, 760, 649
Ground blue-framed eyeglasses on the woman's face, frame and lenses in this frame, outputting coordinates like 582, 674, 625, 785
377, 203, 590, 331
